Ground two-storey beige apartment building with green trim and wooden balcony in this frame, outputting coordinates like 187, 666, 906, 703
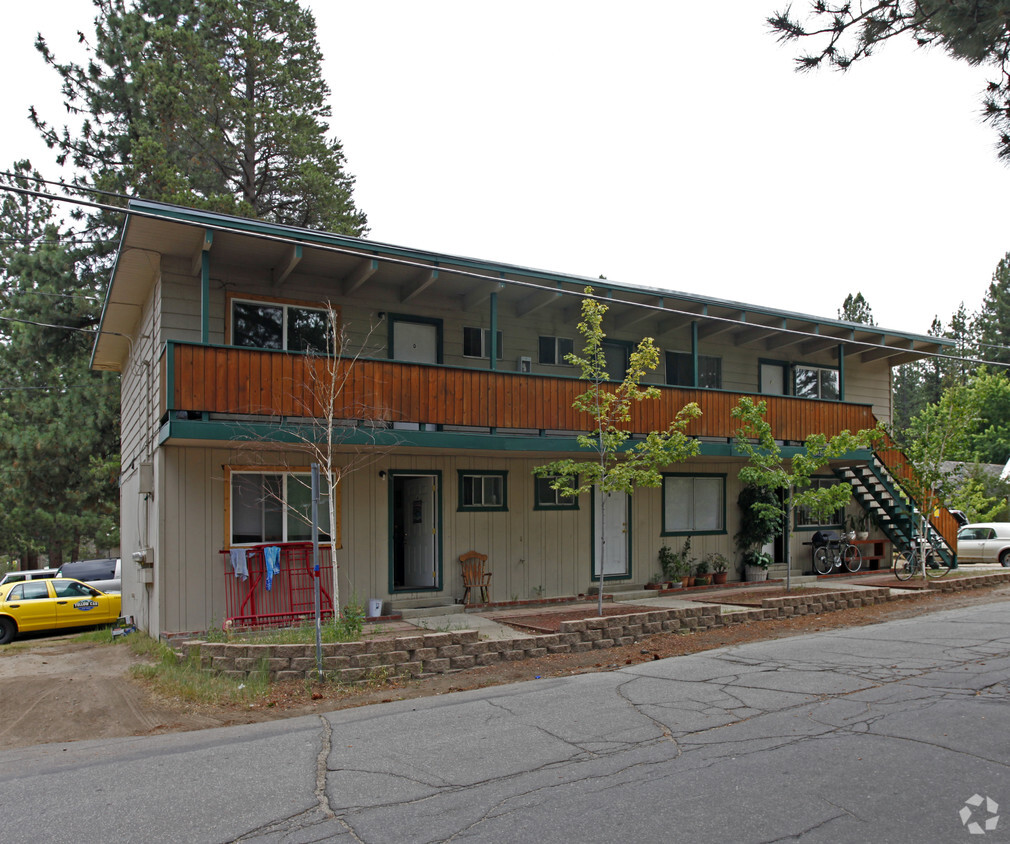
92, 201, 955, 633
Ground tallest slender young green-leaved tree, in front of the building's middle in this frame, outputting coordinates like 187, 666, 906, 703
533, 287, 701, 616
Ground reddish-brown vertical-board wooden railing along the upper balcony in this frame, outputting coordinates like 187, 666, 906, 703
162, 342, 877, 440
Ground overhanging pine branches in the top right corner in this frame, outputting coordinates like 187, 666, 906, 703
768, 0, 1010, 161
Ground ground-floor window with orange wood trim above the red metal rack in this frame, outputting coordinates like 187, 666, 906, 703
229, 470, 329, 545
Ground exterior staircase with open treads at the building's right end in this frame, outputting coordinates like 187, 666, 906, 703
834, 452, 956, 566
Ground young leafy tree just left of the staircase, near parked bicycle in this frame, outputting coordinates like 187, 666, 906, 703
731, 396, 877, 589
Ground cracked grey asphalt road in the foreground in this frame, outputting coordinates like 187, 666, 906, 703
0, 603, 1010, 844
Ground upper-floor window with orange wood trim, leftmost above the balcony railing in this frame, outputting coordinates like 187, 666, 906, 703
231, 299, 329, 352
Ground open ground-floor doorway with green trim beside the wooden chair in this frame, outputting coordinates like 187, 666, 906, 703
392, 474, 438, 591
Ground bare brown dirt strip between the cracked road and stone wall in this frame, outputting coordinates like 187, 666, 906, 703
7, 586, 1010, 748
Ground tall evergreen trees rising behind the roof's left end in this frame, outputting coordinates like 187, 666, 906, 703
32, 0, 367, 235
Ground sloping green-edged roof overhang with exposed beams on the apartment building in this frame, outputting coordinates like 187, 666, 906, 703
92, 201, 952, 370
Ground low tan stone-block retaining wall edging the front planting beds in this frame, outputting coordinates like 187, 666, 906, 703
178, 585, 925, 682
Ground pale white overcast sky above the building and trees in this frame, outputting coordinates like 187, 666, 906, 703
0, 0, 1010, 341
